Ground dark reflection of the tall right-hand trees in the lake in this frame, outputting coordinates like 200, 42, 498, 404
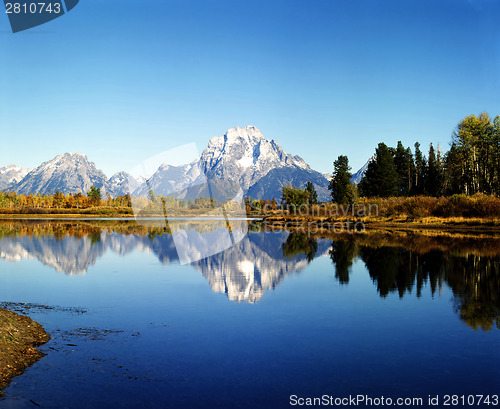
329, 236, 500, 331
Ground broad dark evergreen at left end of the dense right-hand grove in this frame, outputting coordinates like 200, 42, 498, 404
360, 143, 399, 197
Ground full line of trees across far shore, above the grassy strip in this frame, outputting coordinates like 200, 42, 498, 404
0, 113, 500, 213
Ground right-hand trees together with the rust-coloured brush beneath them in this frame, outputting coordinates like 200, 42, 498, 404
260, 113, 500, 217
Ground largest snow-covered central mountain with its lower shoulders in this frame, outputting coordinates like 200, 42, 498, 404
134, 126, 328, 199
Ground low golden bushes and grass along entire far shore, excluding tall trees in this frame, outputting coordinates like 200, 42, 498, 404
0, 192, 500, 230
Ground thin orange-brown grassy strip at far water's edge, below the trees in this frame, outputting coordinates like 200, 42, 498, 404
0, 194, 500, 227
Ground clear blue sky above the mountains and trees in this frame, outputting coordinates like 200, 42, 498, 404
0, 0, 500, 176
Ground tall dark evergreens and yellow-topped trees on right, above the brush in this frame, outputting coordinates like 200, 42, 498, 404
338, 113, 500, 203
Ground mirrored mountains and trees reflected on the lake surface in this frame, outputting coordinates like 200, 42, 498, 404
0, 221, 500, 331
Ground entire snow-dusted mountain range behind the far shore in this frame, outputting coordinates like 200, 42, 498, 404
0, 126, 366, 200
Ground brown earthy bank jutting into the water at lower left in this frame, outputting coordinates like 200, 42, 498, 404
0, 308, 50, 394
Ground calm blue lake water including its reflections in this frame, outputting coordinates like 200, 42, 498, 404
0, 221, 500, 408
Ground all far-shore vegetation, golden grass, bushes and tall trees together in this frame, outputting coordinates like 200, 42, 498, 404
0, 113, 500, 229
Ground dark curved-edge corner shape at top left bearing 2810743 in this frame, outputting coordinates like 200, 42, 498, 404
4, 0, 79, 33
